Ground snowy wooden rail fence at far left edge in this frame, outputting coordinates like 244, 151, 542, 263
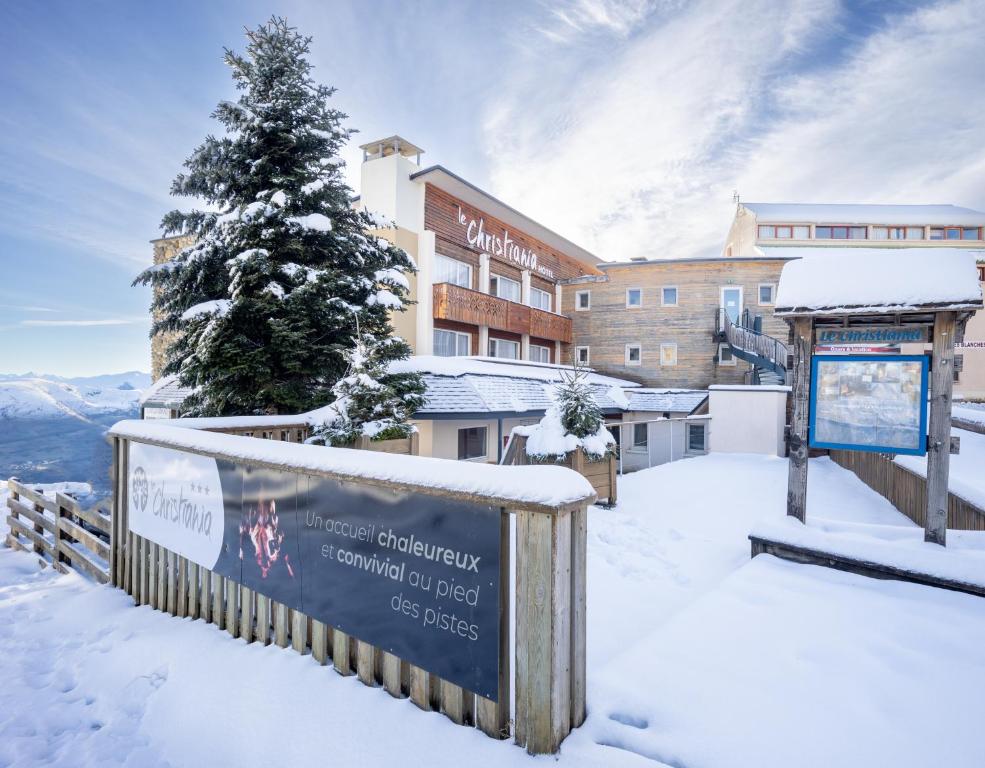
7, 478, 112, 583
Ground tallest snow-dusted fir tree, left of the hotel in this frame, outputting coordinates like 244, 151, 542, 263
135, 17, 415, 415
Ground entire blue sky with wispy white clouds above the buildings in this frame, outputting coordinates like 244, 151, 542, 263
0, 0, 985, 375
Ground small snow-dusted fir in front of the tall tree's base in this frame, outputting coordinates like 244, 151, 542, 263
310, 336, 424, 445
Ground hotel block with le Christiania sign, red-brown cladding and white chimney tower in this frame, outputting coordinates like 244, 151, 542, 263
357, 136, 601, 363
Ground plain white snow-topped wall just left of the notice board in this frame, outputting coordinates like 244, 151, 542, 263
708, 385, 790, 456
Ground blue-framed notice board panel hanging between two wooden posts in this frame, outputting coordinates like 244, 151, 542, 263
810, 355, 928, 456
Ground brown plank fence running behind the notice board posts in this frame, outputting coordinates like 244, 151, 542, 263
830, 450, 985, 531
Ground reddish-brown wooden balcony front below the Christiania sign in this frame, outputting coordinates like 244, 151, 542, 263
434, 283, 572, 344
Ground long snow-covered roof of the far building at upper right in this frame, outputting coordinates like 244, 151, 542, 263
742, 203, 985, 227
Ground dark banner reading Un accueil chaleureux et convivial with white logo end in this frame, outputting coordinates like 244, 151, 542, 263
128, 442, 501, 701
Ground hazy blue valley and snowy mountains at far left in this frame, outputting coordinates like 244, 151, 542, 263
0, 371, 150, 495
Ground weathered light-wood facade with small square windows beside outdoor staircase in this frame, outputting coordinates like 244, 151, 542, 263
561, 258, 787, 389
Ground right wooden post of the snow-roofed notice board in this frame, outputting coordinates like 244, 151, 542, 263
924, 312, 955, 546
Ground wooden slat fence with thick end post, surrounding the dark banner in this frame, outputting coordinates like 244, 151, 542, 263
110, 425, 595, 754
